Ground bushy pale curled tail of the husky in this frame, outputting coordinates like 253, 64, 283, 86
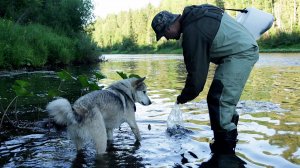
46, 98, 77, 125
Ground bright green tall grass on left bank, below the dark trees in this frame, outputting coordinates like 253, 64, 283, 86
0, 19, 100, 69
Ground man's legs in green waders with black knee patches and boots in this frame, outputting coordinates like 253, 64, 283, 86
207, 46, 259, 153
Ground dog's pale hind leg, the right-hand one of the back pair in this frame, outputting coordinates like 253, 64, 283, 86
89, 108, 107, 154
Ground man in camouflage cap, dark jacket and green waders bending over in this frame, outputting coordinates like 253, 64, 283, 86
151, 4, 259, 154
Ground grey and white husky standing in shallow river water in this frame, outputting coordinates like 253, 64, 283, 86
46, 77, 151, 154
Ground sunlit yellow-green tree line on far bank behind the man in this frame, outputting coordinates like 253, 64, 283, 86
93, 0, 300, 52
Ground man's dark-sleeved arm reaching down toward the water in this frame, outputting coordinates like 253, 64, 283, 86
177, 30, 210, 104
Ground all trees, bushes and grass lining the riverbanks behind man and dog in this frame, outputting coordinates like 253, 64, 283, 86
0, 0, 300, 71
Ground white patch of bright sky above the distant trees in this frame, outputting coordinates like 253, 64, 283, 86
93, 0, 161, 18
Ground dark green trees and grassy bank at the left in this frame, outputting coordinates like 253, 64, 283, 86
0, 0, 100, 69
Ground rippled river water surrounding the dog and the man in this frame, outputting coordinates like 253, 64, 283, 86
0, 53, 300, 168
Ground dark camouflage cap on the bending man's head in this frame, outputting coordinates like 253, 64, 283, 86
151, 11, 180, 41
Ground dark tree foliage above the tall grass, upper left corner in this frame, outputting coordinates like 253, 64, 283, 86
0, 0, 93, 33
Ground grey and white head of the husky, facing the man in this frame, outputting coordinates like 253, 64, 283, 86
131, 77, 151, 106
